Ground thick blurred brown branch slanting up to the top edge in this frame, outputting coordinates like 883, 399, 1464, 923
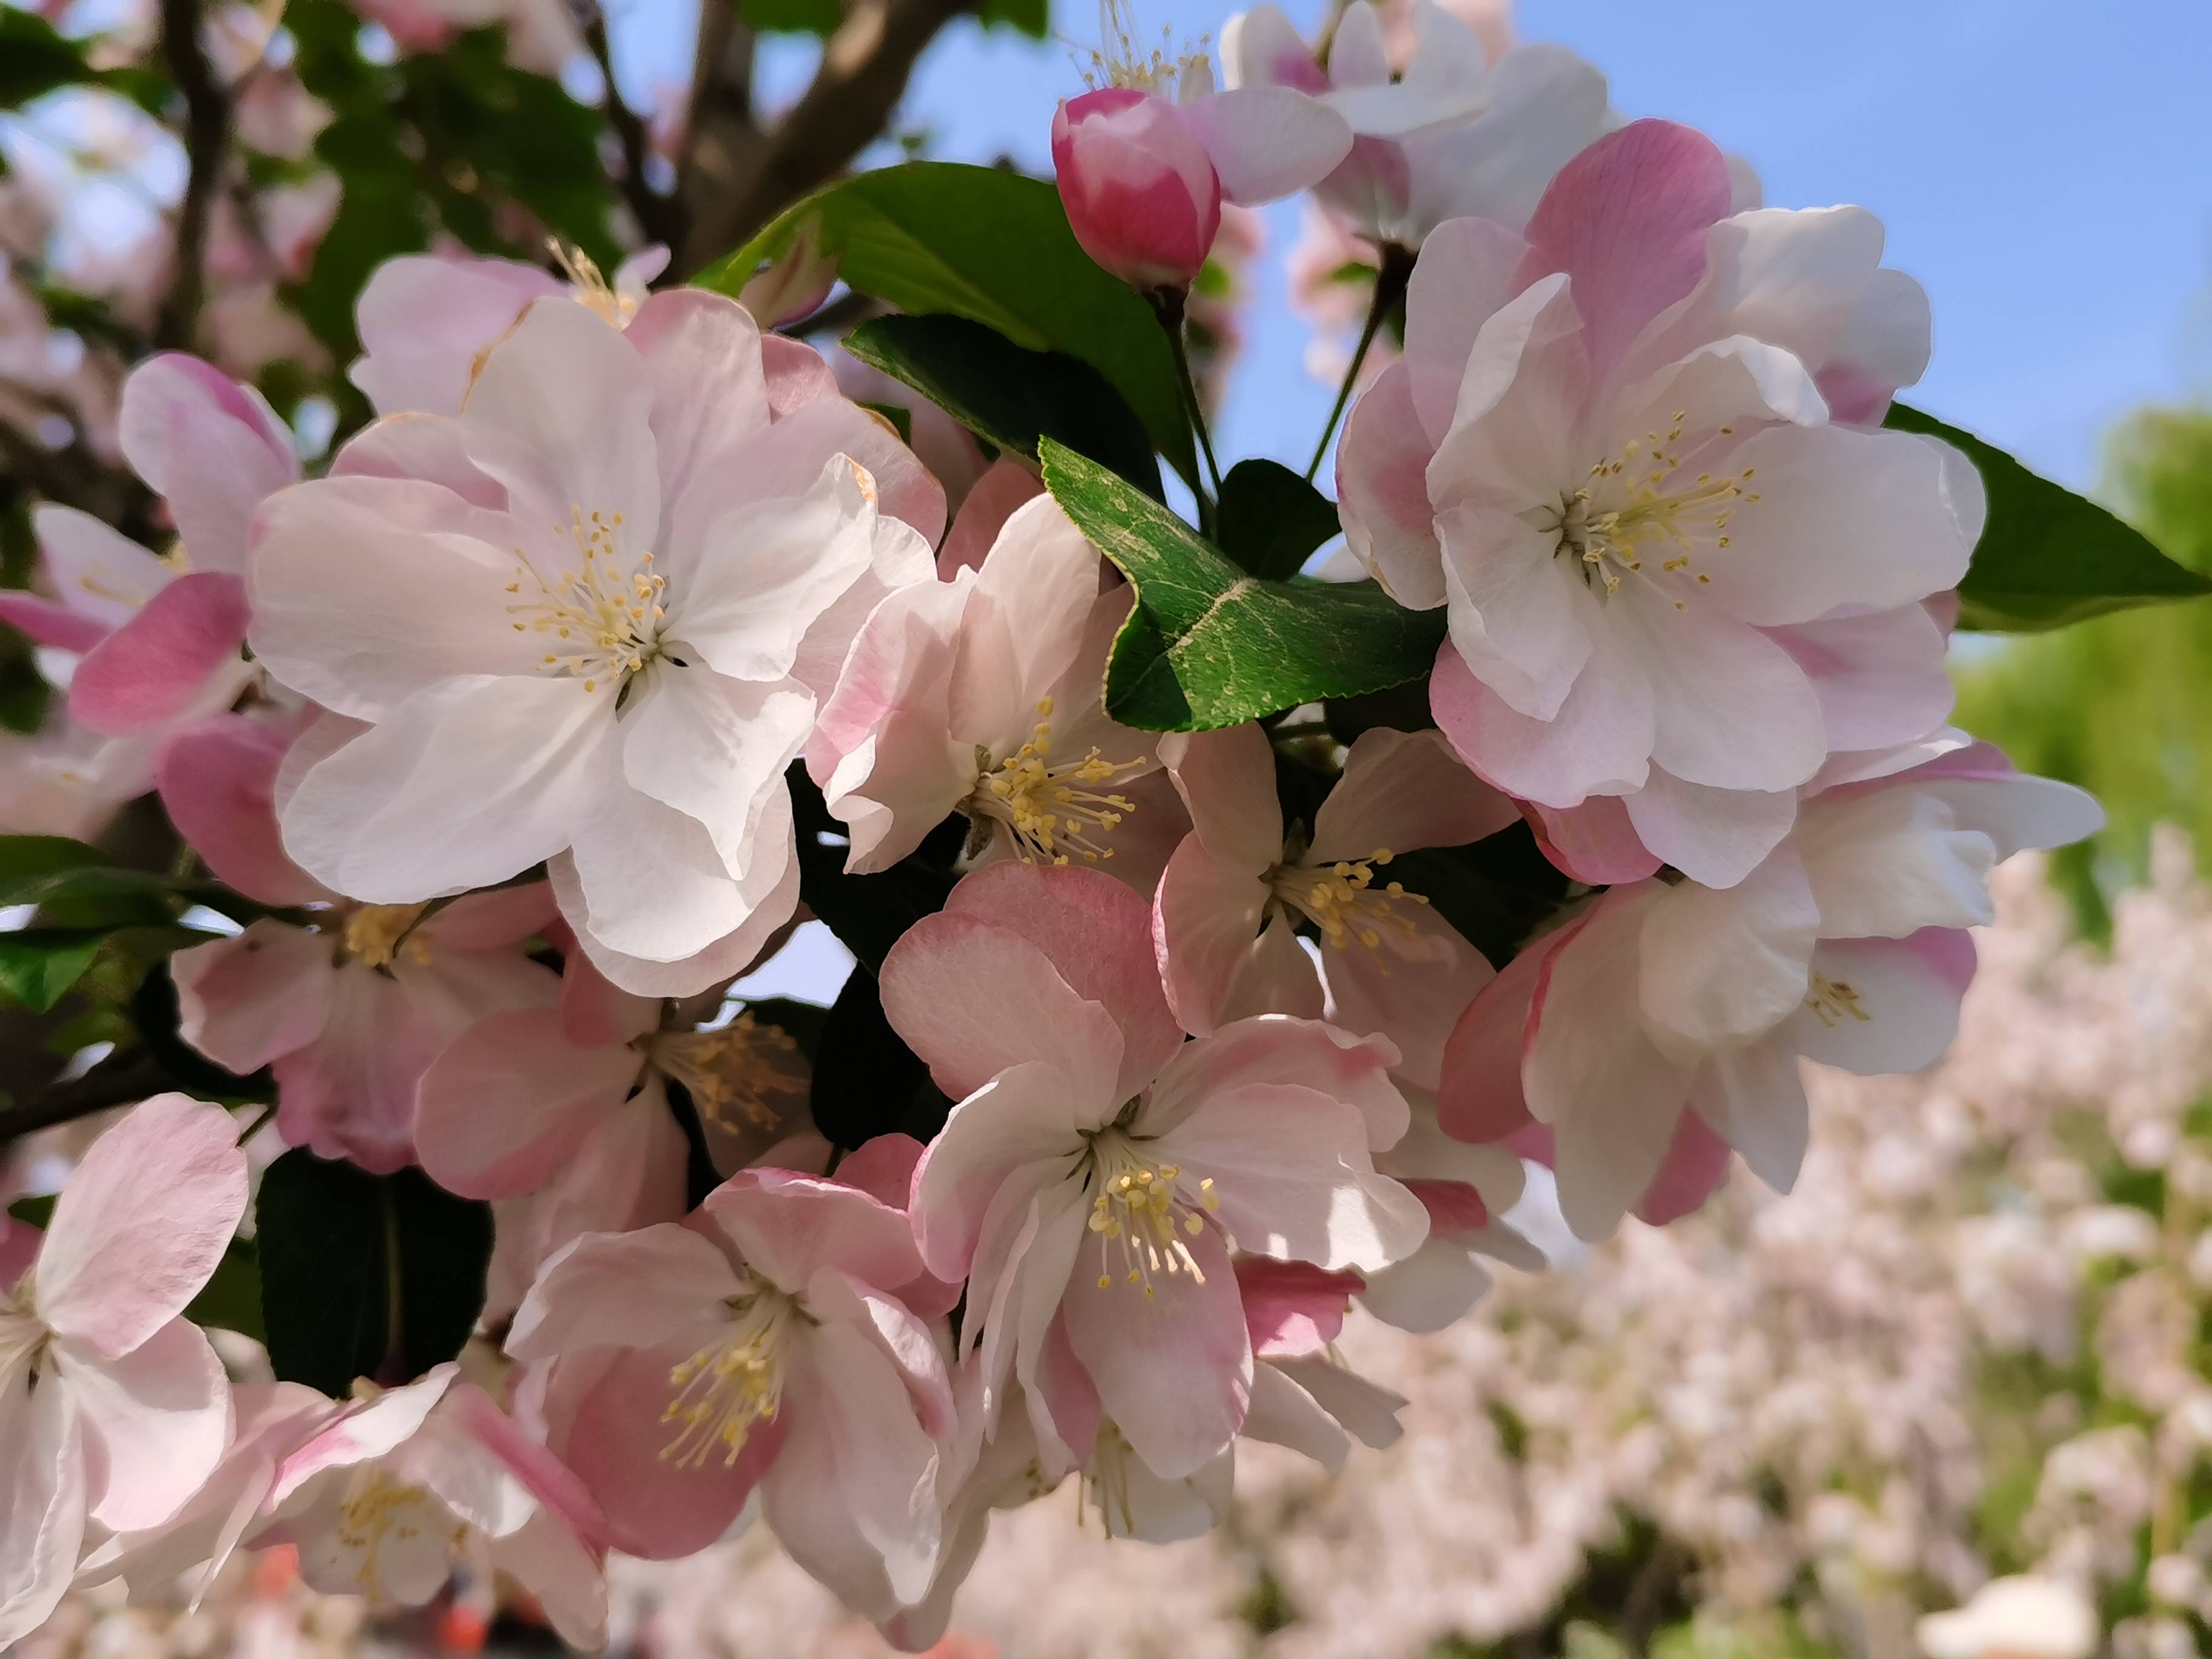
683, 0, 976, 270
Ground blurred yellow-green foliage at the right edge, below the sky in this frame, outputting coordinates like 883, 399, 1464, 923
1957, 409, 2212, 936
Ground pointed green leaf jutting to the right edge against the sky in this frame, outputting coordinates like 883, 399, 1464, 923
1882, 403, 2212, 632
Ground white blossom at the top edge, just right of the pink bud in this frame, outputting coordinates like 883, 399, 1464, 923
1221, 0, 1610, 252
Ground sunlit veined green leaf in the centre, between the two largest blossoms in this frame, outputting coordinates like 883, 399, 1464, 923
1044, 440, 1444, 732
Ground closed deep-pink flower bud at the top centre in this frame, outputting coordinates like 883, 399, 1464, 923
1053, 86, 1221, 290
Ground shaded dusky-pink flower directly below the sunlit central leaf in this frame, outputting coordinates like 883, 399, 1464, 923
1153, 726, 1520, 1039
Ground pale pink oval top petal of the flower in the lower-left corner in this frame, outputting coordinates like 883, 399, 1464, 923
35, 1095, 246, 1358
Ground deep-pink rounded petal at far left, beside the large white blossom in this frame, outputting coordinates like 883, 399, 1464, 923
69, 571, 252, 737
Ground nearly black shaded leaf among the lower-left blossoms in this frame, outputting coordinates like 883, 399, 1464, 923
255, 1148, 491, 1396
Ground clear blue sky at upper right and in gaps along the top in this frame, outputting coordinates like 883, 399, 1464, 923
617, 0, 2212, 487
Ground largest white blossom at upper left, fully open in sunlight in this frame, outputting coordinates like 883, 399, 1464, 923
252, 290, 942, 996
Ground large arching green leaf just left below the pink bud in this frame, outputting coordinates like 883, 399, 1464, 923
694, 161, 1197, 480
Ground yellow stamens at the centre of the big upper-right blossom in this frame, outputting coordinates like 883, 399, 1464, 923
1537, 409, 1758, 611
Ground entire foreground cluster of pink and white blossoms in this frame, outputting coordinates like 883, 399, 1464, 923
0, 0, 2141, 1648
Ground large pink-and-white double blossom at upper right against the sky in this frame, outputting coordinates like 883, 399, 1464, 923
1338, 122, 1984, 885
